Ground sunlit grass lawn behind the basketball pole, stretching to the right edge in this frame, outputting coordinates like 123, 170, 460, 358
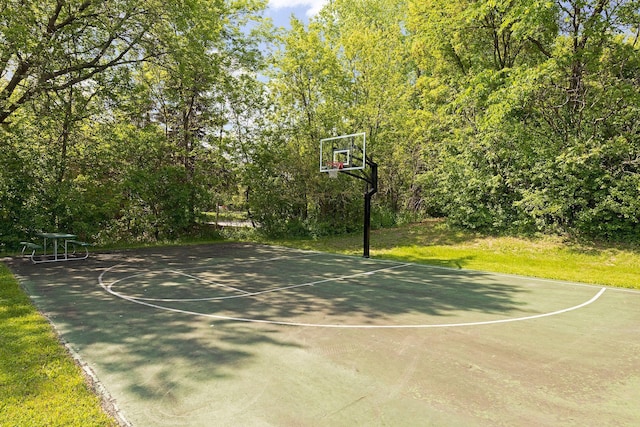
274, 220, 640, 289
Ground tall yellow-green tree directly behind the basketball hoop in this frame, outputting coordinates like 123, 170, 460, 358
270, 0, 415, 234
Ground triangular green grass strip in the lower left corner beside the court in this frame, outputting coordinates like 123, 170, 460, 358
0, 263, 117, 427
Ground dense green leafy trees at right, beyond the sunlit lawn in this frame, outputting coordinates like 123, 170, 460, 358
410, 0, 639, 236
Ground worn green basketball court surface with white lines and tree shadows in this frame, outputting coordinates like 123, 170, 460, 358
9, 244, 640, 426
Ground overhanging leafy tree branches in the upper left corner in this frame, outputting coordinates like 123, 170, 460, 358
0, 0, 163, 124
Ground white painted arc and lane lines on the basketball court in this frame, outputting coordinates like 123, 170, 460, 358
98, 252, 608, 329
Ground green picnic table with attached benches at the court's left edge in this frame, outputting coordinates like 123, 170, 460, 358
20, 233, 91, 264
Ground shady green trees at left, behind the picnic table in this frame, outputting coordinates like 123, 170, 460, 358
0, 0, 265, 244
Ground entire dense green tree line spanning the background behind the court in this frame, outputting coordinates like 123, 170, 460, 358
0, 0, 640, 245
